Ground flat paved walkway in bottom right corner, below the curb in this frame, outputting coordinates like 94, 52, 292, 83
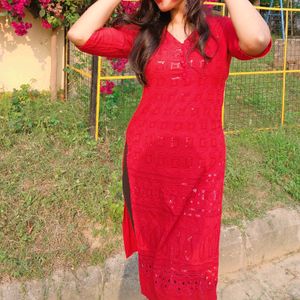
218, 253, 300, 300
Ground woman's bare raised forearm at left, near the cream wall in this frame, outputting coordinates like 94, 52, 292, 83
67, 0, 121, 46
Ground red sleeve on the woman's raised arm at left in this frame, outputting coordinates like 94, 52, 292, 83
75, 24, 139, 58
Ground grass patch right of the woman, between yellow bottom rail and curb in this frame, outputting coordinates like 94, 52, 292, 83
223, 127, 300, 225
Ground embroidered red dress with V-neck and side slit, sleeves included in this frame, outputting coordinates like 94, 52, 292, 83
78, 15, 272, 300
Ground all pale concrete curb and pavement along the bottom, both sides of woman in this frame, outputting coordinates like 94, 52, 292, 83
0, 207, 300, 300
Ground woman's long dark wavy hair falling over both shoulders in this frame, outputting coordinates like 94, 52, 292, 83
111, 0, 216, 85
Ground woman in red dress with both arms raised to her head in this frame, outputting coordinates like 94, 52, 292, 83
68, 0, 272, 300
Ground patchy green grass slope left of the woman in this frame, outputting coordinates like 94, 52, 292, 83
0, 86, 123, 280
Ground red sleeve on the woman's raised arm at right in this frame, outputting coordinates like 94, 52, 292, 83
220, 16, 273, 60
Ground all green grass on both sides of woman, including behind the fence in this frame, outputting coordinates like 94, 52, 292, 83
0, 62, 300, 281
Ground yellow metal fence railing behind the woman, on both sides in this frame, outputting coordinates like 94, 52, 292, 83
67, 1, 300, 140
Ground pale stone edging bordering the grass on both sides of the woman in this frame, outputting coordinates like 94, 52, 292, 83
0, 208, 300, 300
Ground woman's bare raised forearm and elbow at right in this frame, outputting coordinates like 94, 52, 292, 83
225, 0, 271, 55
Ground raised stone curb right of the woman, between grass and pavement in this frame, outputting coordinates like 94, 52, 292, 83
219, 208, 300, 274
